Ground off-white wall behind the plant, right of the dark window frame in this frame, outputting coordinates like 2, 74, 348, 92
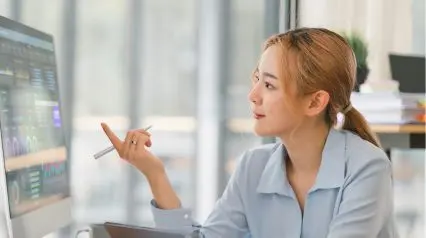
299, 0, 425, 90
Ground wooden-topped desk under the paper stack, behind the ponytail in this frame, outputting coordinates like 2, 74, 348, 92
370, 124, 426, 158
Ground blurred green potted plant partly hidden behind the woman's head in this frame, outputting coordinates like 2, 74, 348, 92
343, 33, 370, 92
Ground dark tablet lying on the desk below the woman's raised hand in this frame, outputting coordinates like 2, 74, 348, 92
102, 222, 199, 238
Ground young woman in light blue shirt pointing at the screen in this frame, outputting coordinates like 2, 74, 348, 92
102, 28, 397, 238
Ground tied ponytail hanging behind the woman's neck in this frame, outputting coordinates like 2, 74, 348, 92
342, 105, 381, 148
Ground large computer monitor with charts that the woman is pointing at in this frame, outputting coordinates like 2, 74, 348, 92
0, 17, 71, 238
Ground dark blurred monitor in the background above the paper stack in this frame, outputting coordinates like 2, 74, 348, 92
389, 54, 425, 93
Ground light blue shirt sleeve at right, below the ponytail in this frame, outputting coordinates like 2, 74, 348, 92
327, 159, 396, 238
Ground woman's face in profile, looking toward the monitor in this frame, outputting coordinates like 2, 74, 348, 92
248, 46, 306, 137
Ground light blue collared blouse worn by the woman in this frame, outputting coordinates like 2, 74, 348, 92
151, 129, 398, 238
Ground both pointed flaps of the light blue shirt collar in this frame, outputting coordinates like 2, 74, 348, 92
256, 128, 346, 197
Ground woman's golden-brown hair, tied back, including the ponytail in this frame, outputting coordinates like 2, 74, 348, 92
263, 28, 380, 147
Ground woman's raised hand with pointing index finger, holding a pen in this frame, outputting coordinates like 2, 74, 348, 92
101, 123, 165, 179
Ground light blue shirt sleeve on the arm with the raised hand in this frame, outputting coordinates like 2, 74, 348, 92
151, 152, 248, 238
